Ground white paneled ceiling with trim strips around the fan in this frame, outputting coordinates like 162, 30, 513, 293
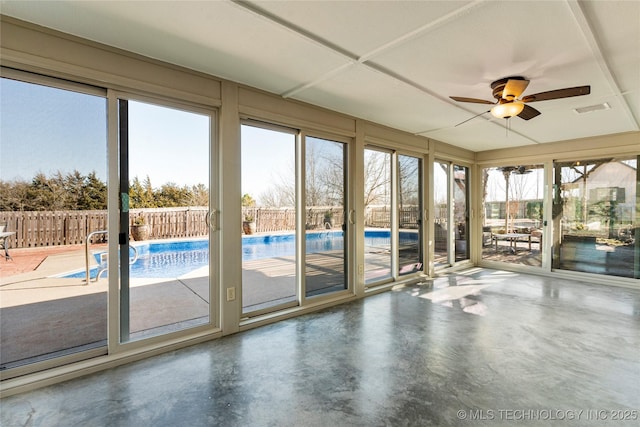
0, 0, 640, 151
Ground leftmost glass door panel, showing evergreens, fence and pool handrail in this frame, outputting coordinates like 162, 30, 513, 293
0, 74, 108, 372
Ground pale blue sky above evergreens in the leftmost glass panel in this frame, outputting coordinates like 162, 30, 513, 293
0, 78, 107, 181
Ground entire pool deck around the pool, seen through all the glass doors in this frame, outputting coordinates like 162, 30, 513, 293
0, 239, 424, 368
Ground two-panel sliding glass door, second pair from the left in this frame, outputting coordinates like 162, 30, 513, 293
241, 121, 349, 317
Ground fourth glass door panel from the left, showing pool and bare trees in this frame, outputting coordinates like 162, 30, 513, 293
305, 137, 347, 297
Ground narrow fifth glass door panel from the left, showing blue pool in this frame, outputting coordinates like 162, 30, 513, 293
364, 148, 392, 284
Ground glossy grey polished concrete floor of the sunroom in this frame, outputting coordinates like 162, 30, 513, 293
0, 269, 640, 426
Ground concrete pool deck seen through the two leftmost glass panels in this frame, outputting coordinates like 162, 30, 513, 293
0, 245, 209, 367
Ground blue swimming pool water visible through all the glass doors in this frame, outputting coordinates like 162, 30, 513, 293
64, 230, 418, 278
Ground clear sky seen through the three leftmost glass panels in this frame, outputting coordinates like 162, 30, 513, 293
0, 78, 316, 201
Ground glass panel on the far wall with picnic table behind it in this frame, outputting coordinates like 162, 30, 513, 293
482, 165, 544, 267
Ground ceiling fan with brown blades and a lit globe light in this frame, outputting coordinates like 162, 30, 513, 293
450, 76, 591, 126
